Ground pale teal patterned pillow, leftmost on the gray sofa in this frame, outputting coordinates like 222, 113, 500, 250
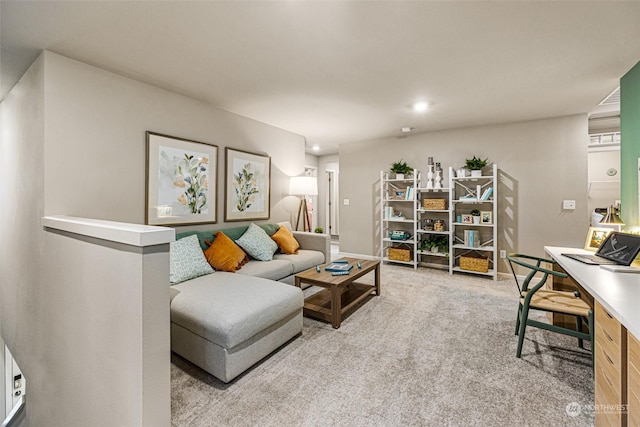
169, 234, 213, 285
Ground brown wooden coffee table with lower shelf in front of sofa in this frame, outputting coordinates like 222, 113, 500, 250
295, 258, 380, 329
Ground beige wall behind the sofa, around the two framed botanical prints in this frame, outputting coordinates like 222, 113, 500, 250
45, 52, 305, 230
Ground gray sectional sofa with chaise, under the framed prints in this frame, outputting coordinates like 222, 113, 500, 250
171, 222, 331, 382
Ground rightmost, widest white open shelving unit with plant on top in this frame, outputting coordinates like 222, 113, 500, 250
449, 164, 498, 280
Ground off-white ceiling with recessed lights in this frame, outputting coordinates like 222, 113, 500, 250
0, 0, 640, 155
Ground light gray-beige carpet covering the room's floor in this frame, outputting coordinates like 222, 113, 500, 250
171, 264, 593, 427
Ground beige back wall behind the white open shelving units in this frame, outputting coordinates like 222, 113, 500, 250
340, 115, 588, 272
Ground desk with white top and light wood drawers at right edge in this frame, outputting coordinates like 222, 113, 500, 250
544, 246, 640, 426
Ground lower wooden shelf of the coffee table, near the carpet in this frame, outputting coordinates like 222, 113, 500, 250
304, 282, 376, 328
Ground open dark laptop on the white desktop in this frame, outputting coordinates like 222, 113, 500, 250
562, 232, 640, 266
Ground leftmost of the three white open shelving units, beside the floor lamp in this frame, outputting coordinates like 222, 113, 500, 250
380, 170, 420, 269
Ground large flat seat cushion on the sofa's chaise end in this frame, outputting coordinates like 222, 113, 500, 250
171, 272, 304, 349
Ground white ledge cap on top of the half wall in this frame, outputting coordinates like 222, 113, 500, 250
42, 215, 176, 247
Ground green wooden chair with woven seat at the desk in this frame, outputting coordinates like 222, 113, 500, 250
507, 254, 595, 364
